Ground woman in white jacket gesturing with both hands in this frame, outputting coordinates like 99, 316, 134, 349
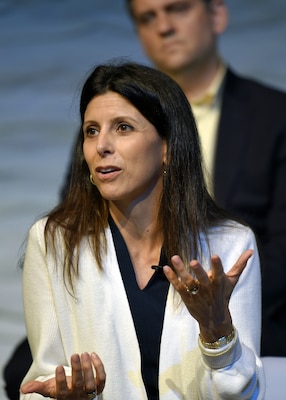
21, 63, 264, 400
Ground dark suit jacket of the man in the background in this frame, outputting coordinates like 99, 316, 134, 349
214, 70, 286, 356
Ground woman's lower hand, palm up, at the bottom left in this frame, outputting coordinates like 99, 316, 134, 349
21, 353, 106, 400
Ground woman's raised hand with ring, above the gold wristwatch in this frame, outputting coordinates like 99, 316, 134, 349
164, 250, 253, 342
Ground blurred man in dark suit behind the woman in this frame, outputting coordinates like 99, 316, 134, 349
127, 0, 286, 356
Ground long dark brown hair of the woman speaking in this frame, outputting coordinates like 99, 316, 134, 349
46, 62, 228, 284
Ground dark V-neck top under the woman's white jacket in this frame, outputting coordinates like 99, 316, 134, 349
109, 218, 169, 400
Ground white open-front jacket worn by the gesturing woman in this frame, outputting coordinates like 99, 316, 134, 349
21, 219, 265, 400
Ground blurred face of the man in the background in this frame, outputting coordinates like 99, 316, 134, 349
131, 0, 219, 75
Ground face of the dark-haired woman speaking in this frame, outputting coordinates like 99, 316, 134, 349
83, 92, 166, 206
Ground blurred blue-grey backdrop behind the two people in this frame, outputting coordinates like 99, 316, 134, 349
0, 0, 286, 400
